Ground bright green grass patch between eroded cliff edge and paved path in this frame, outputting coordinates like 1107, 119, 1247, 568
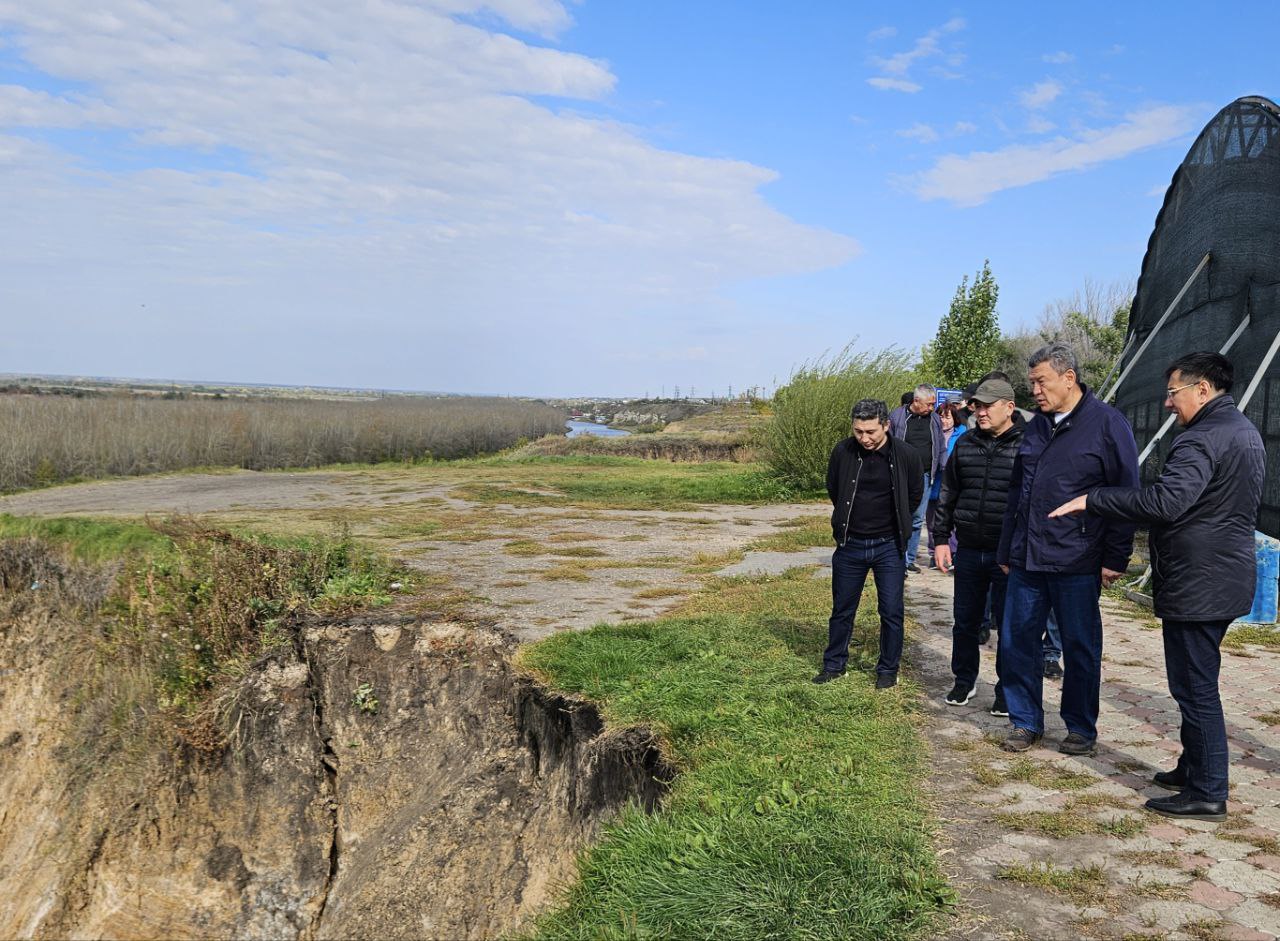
518, 571, 952, 938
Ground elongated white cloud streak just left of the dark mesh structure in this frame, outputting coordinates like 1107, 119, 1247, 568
904, 105, 1194, 206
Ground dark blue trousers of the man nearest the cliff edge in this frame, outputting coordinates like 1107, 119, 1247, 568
822, 536, 906, 673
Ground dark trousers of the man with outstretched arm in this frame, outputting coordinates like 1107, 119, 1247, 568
1164, 618, 1228, 800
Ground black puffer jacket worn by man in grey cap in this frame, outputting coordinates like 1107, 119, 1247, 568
933, 411, 1027, 552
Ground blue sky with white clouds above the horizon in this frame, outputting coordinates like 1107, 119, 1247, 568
0, 0, 1280, 396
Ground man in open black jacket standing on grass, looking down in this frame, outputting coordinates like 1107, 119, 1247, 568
813, 398, 924, 689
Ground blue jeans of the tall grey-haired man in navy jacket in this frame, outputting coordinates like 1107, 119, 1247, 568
1000, 566, 1102, 741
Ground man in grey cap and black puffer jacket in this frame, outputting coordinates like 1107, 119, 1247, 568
933, 379, 1024, 716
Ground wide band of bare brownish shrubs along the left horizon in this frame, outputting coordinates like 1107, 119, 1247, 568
0, 396, 564, 490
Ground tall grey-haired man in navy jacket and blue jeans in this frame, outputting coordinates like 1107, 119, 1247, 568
996, 343, 1138, 755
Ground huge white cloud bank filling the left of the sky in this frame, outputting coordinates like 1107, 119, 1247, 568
0, 0, 859, 390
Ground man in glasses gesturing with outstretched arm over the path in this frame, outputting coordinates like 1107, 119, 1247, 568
1050, 353, 1266, 821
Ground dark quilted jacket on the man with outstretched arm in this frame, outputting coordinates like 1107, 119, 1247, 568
1088, 396, 1267, 621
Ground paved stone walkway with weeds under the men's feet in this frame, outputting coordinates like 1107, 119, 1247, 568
908, 571, 1280, 940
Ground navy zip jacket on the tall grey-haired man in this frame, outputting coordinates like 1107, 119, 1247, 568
996, 384, 1138, 575
